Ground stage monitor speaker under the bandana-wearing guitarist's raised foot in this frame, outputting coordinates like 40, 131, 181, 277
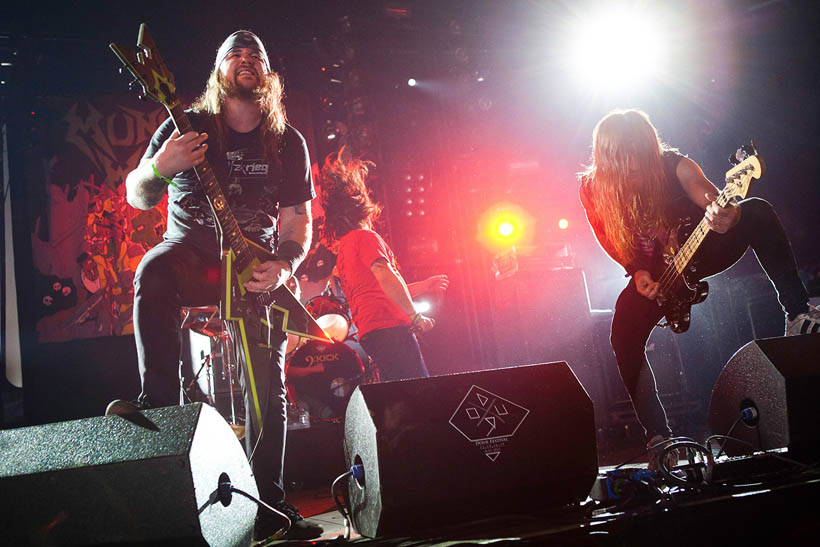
0, 403, 257, 546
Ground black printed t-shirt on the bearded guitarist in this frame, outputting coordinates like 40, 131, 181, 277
143, 111, 316, 253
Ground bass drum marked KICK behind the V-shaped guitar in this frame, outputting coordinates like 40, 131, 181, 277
285, 340, 364, 421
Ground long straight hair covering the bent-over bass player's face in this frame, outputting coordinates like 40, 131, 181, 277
581, 110, 672, 263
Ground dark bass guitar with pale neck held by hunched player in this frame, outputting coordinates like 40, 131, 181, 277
653, 143, 766, 334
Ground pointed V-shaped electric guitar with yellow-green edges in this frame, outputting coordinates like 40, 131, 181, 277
109, 23, 331, 423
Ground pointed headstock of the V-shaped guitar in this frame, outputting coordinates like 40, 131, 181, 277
109, 23, 179, 110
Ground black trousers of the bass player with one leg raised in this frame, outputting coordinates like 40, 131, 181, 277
611, 198, 809, 439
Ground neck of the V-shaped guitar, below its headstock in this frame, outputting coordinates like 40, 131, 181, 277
168, 102, 253, 270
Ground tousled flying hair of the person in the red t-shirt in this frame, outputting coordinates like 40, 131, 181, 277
319, 148, 381, 249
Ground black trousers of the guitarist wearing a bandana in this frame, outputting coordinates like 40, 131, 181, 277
134, 241, 287, 503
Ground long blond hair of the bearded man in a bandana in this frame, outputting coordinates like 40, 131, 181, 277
191, 65, 288, 163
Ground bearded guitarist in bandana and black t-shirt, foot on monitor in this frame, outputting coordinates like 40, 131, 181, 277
115, 30, 322, 539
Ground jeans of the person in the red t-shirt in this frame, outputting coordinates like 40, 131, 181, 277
360, 327, 430, 381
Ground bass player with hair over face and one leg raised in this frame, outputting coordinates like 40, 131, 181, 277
580, 110, 820, 468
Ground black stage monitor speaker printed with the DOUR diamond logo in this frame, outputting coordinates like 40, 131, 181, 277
345, 362, 598, 537
